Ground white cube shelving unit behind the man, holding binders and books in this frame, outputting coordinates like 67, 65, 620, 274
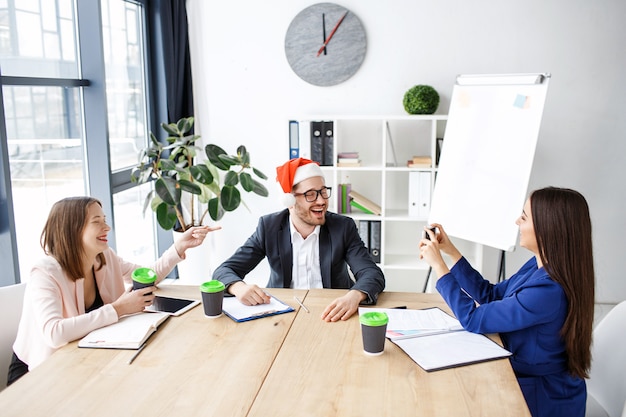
292, 115, 482, 291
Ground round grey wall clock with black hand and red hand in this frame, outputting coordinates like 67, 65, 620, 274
285, 3, 367, 86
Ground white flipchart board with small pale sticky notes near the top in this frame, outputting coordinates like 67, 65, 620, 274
429, 74, 550, 251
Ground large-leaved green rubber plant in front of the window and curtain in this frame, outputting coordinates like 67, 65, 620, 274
131, 117, 269, 231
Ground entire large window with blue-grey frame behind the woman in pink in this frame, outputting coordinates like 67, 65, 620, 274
0, 0, 156, 285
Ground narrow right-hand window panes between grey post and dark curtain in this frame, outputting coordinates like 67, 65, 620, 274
102, 0, 156, 264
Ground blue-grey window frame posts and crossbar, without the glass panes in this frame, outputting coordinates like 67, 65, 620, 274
0, 0, 168, 286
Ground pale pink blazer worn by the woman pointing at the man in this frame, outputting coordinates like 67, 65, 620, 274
13, 246, 182, 370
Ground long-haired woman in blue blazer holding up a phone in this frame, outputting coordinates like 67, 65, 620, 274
420, 187, 595, 417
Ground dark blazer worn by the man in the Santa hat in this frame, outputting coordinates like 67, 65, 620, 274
213, 209, 385, 304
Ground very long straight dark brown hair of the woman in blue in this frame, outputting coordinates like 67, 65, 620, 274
530, 187, 595, 378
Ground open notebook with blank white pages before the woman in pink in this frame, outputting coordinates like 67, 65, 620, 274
78, 313, 170, 349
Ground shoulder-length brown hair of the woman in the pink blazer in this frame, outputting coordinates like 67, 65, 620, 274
39, 197, 106, 281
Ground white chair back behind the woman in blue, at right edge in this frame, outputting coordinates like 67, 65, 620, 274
586, 301, 626, 417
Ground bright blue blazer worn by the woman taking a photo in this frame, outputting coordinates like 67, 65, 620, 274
437, 257, 587, 417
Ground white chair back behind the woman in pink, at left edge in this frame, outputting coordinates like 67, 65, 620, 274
0, 283, 26, 391
